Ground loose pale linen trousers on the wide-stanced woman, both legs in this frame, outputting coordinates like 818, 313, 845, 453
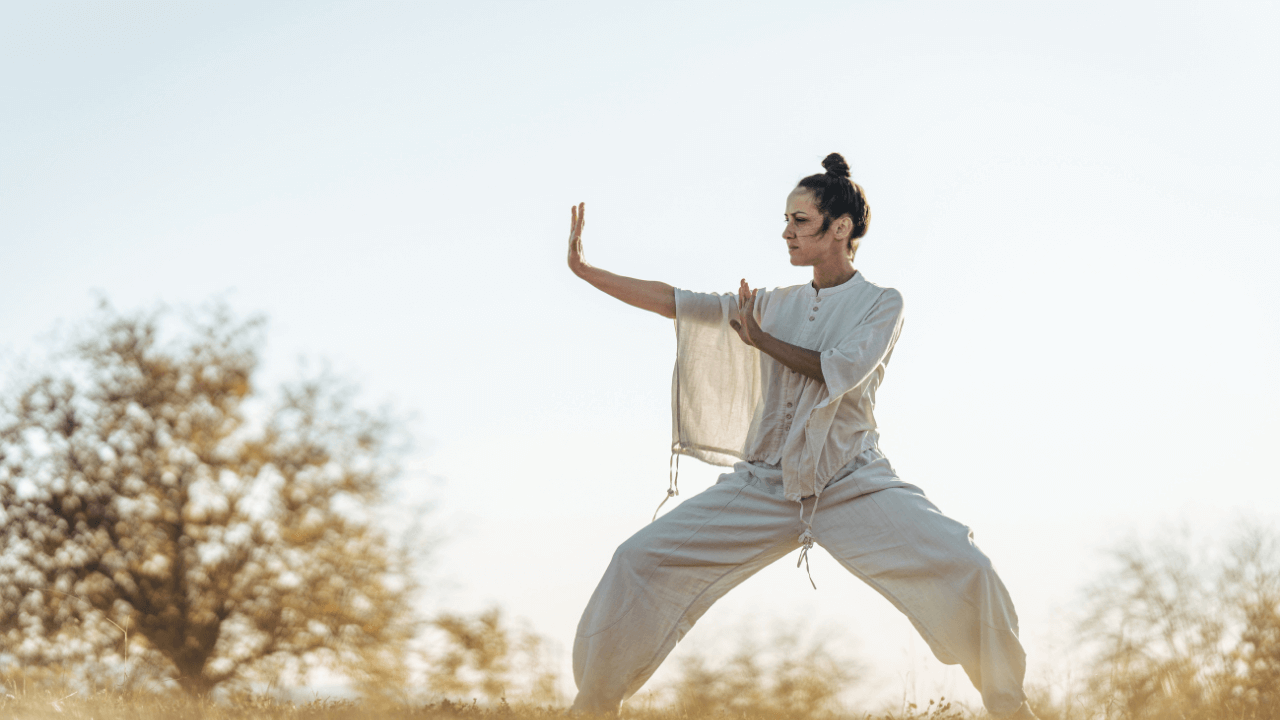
573, 447, 1025, 715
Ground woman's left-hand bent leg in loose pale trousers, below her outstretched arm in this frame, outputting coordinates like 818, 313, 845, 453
573, 470, 800, 712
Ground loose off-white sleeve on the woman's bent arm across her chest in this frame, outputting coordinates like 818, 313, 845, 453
818, 288, 902, 407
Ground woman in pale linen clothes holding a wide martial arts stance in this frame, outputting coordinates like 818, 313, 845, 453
568, 154, 1034, 717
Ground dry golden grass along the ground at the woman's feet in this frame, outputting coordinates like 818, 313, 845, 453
0, 659, 1280, 720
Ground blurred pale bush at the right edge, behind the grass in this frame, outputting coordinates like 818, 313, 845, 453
1080, 525, 1280, 720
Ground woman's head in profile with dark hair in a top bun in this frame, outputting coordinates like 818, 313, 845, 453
783, 152, 872, 264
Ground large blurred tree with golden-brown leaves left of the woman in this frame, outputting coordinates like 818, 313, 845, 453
0, 302, 415, 696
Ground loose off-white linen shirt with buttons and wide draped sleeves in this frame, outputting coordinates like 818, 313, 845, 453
671, 272, 902, 501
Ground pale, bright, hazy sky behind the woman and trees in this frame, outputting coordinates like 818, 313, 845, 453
0, 0, 1280, 702
